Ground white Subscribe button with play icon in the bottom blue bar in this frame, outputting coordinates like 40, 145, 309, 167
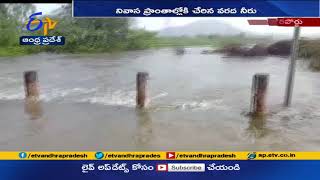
160, 163, 205, 172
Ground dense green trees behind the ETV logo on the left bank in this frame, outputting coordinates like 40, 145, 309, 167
0, 4, 156, 56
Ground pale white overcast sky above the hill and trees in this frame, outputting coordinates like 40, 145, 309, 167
35, 4, 320, 37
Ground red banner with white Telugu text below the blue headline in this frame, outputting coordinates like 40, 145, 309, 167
248, 18, 320, 27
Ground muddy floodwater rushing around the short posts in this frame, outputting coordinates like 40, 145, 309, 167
0, 48, 320, 151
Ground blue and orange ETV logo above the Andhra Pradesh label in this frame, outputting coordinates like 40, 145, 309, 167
26, 12, 58, 36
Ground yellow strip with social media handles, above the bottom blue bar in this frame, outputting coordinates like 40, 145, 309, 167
0, 151, 320, 160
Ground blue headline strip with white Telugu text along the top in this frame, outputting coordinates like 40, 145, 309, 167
73, 0, 319, 17
